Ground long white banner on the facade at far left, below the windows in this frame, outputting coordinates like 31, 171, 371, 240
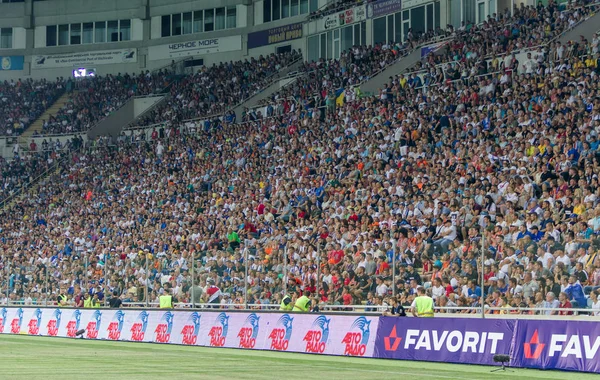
31, 49, 137, 69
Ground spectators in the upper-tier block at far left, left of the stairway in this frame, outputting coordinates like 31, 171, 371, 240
0, 78, 67, 136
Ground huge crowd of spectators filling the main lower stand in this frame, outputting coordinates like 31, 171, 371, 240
0, 4, 600, 315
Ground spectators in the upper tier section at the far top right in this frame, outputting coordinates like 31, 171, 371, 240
413, 1, 597, 79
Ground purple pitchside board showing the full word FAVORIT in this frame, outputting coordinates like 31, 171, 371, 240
374, 317, 515, 364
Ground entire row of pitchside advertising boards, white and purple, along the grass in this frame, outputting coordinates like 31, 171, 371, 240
0, 307, 600, 372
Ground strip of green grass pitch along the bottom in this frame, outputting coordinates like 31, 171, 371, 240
0, 335, 600, 380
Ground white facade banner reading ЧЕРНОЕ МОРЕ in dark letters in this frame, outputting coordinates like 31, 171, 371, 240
148, 36, 242, 61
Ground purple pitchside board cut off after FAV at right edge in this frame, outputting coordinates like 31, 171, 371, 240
511, 320, 600, 373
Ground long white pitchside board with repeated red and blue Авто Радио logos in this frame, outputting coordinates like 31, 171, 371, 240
0, 308, 379, 357
